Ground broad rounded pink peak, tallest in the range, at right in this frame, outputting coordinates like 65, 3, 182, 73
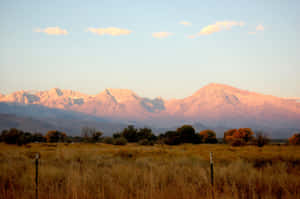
166, 84, 300, 128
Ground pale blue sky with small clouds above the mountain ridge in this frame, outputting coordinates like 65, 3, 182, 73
0, 0, 300, 99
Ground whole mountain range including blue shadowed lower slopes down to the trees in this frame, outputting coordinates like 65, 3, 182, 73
0, 83, 300, 137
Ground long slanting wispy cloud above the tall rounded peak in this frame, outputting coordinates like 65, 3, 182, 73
189, 21, 245, 38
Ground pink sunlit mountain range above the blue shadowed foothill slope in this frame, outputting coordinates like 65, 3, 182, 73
0, 84, 300, 137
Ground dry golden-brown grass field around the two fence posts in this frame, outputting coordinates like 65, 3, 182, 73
0, 143, 300, 199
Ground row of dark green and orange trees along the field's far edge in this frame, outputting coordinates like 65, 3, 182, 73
0, 125, 300, 147
